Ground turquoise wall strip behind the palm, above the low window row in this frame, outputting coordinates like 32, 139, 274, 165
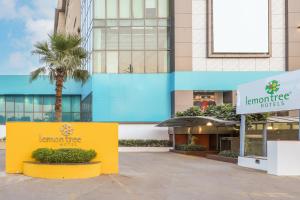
0, 75, 81, 95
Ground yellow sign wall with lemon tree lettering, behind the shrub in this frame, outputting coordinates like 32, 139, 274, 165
6, 122, 118, 174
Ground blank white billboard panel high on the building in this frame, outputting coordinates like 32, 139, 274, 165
212, 0, 269, 53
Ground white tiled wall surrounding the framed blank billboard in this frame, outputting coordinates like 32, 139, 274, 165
192, 0, 285, 71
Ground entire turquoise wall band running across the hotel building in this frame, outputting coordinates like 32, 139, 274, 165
0, 72, 282, 122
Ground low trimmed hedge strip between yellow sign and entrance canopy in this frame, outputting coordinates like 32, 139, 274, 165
119, 140, 171, 147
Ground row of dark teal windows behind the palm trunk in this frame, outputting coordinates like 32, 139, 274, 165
0, 95, 81, 124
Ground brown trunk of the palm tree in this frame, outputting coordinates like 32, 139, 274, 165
55, 74, 64, 122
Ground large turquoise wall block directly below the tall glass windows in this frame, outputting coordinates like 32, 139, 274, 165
92, 74, 171, 122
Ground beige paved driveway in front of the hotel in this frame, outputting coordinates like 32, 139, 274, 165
0, 150, 300, 200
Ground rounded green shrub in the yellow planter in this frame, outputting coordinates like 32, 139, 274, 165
32, 148, 97, 163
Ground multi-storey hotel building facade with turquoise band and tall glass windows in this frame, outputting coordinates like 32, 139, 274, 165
0, 0, 300, 139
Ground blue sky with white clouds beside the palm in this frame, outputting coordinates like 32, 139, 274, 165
0, 0, 57, 75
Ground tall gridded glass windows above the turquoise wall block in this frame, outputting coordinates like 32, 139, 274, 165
93, 0, 170, 73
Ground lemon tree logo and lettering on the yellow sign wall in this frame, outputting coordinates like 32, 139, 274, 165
39, 124, 82, 146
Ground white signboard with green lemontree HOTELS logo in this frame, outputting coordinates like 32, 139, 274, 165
237, 70, 300, 114
